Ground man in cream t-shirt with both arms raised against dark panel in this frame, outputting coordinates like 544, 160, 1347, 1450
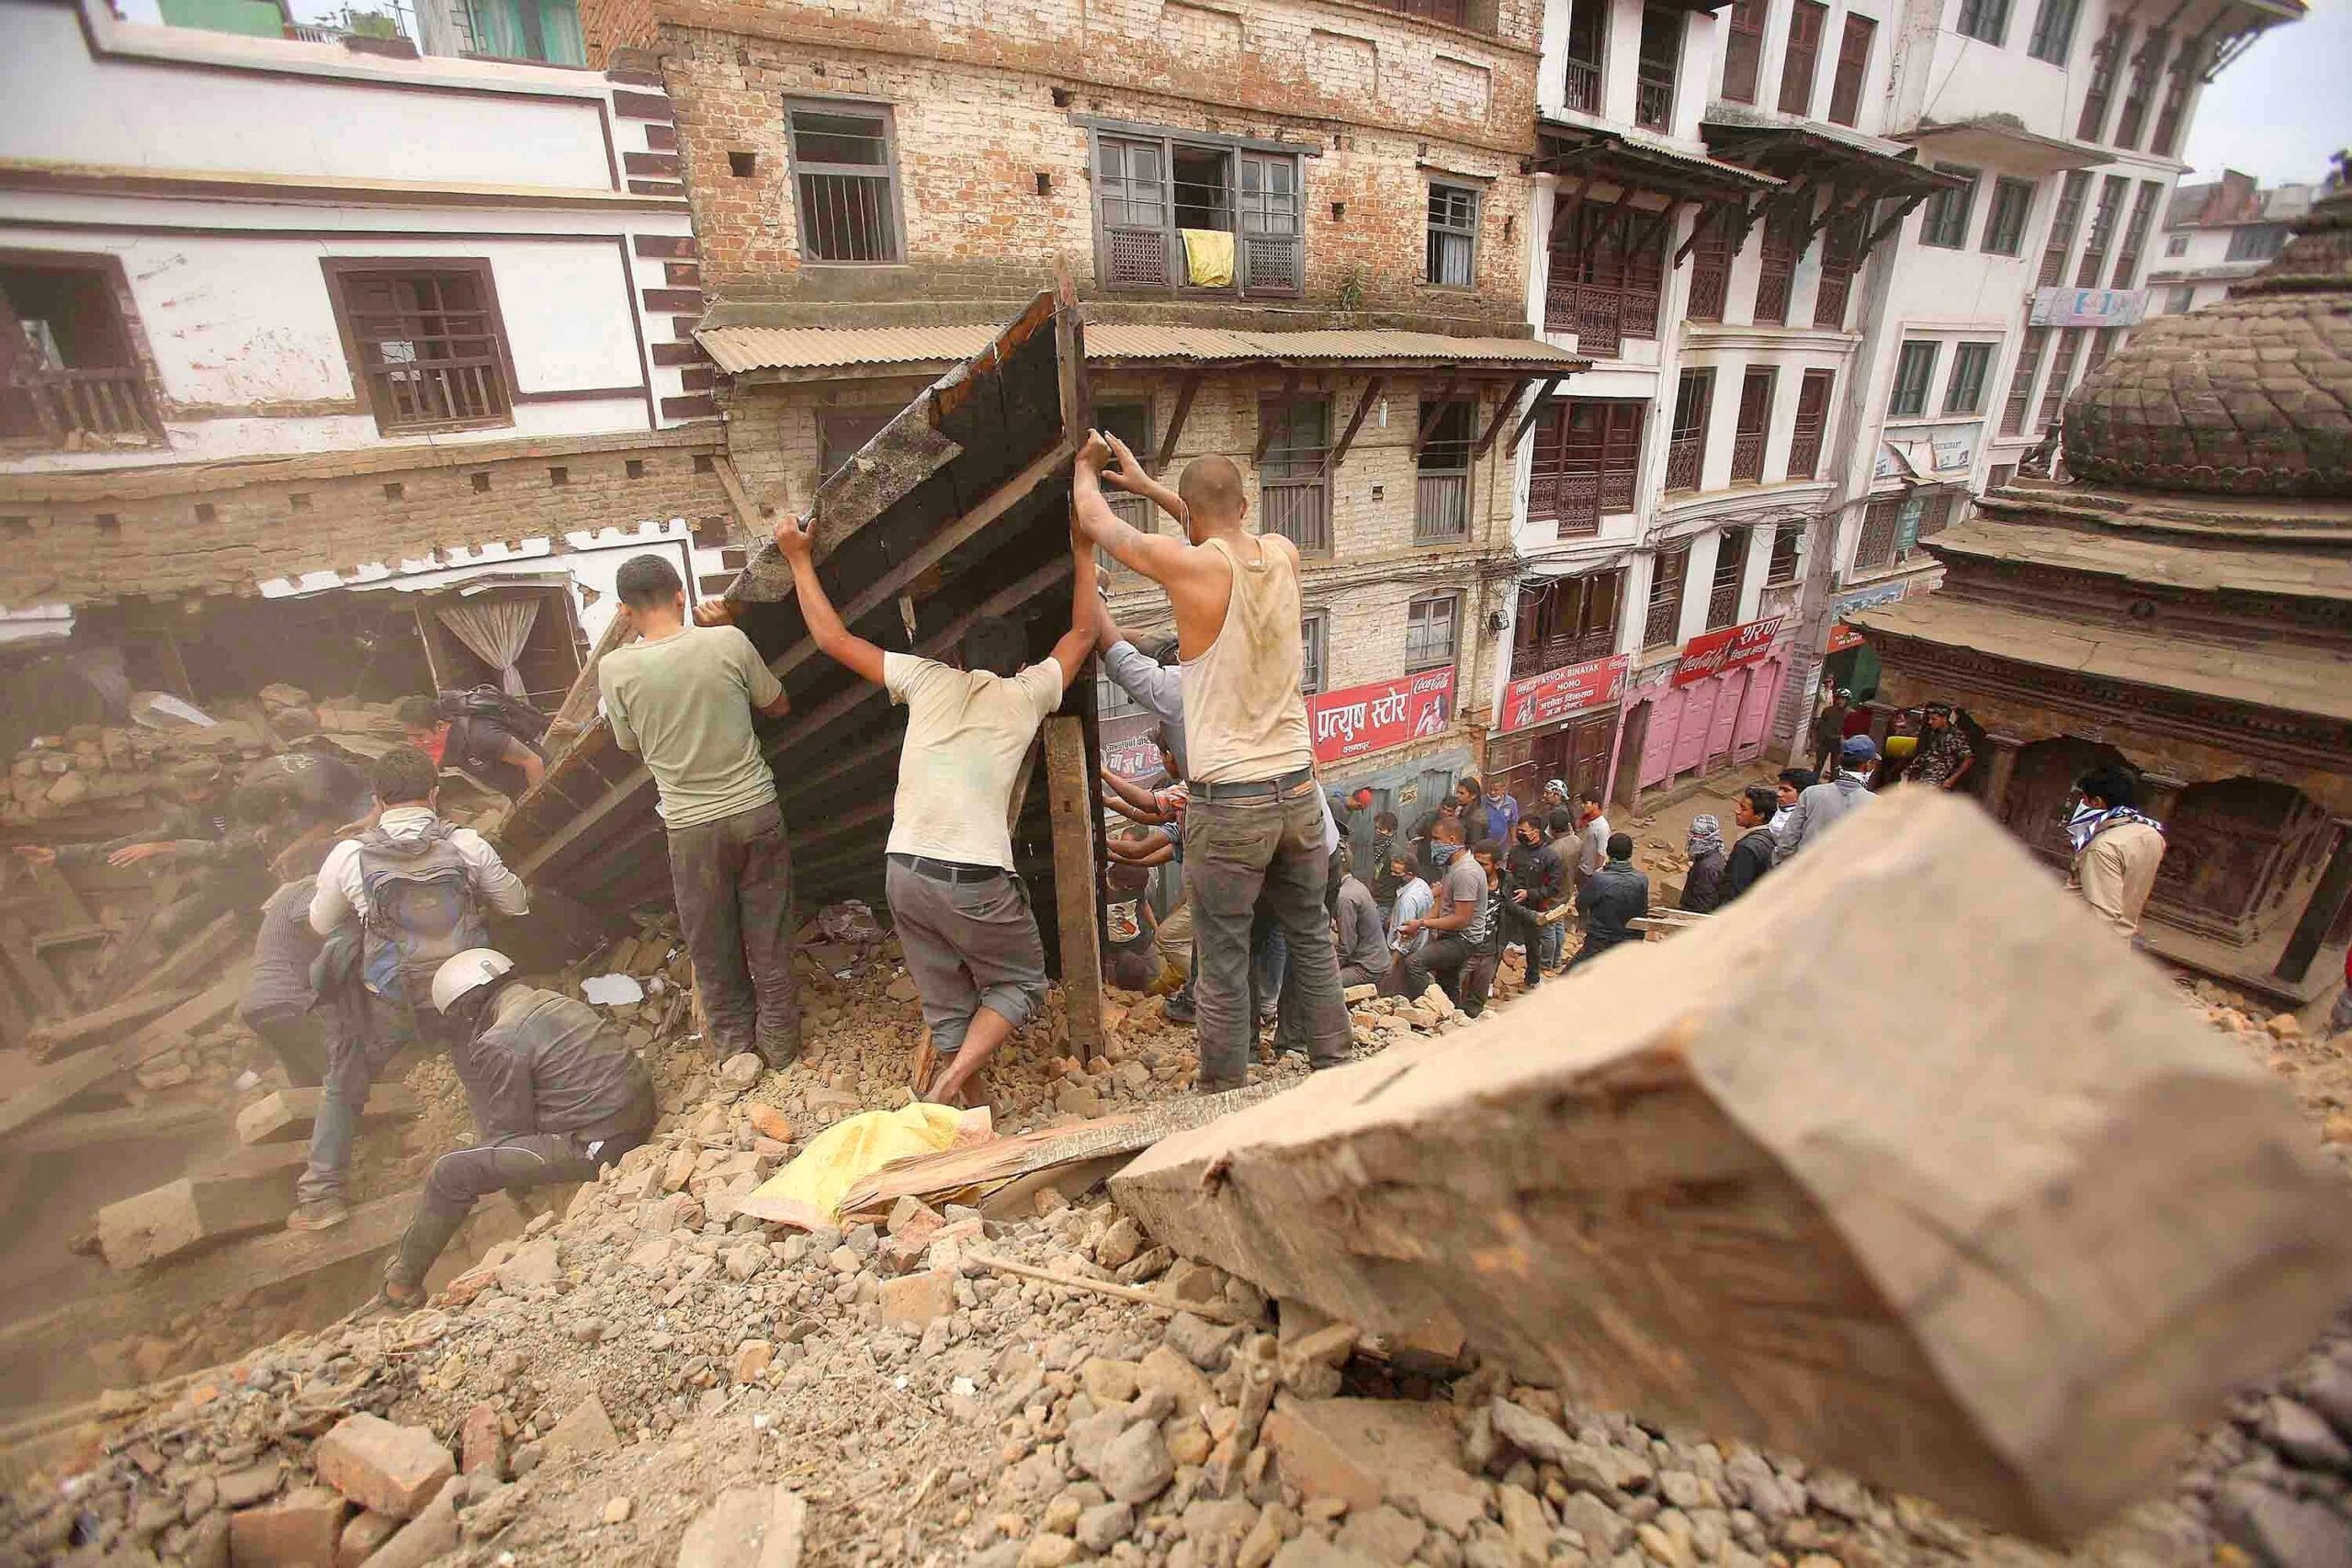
776, 505, 1096, 1105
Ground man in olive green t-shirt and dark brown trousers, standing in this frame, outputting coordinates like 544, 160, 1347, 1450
597, 555, 799, 1067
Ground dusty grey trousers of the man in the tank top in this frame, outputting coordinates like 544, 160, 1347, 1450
1183, 776, 1348, 1090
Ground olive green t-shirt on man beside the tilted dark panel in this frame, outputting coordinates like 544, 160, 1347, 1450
595, 626, 783, 828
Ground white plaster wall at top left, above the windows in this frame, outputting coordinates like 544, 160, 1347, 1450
0, 0, 614, 190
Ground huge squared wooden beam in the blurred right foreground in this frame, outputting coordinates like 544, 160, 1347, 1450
1113, 790, 2352, 1540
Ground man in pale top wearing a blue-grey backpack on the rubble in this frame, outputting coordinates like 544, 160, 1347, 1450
287, 745, 532, 1229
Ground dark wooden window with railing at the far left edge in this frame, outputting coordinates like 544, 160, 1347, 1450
0, 252, 163, 446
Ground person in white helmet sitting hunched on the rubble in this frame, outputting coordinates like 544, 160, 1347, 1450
383, 947, 656, 1307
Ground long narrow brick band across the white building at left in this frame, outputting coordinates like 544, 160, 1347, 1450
0, 425, 729, 604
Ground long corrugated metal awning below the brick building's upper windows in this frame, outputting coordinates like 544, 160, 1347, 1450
694, 322, 1588, 376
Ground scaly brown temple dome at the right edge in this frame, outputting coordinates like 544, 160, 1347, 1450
2063, 190, 2352, 496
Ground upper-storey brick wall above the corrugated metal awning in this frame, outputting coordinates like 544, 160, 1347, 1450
663, 5, 1533, 332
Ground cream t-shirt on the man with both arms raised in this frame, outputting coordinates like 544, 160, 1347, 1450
882, 653, 1061, 870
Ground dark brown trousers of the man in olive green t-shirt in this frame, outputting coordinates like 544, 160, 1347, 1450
671, 802, 799, 1067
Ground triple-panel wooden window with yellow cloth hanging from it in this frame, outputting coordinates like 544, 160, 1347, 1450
1087, 125, 1307, 301
